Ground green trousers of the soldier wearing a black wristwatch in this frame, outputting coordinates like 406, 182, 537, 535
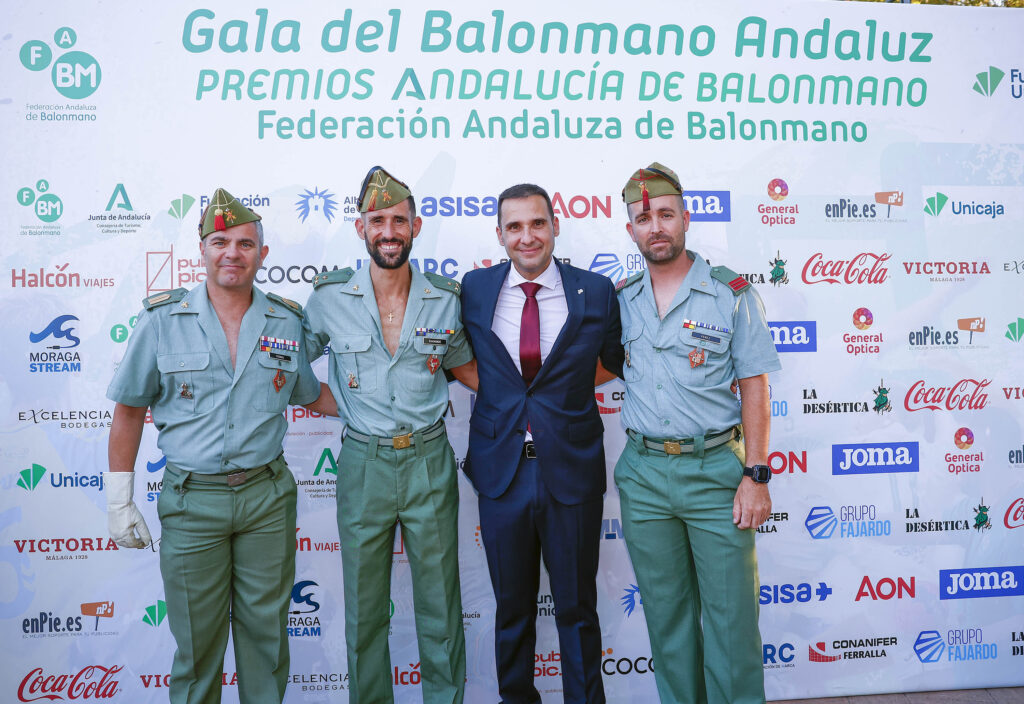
615, 435, 765, 704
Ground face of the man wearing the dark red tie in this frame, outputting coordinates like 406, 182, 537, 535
497, 195, 558, 280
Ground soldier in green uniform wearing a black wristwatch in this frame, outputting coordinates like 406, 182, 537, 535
615, 163, 779, 704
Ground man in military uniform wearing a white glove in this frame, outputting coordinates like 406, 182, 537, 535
104, 188, 325, 704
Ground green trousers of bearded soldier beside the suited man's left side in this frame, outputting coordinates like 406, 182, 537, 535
338, 423, 466, 704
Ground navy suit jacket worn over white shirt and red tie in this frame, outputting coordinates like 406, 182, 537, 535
462, 260, 624, 504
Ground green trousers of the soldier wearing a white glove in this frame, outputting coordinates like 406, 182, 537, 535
158, 457, 296, 704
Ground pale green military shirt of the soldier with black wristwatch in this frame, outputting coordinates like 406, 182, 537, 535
618, 250, 781, 438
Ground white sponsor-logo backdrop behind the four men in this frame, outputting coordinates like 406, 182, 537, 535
0, 0, 1024, 704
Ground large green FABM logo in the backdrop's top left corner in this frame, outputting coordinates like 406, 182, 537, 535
18, 27, 102, 108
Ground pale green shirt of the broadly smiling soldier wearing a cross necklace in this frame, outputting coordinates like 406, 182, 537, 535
305, 266, 473, 436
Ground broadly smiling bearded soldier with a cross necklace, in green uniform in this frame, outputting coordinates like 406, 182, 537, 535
306, 167, 475, 704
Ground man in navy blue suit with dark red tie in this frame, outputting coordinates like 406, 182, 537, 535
462, 184, 623, 704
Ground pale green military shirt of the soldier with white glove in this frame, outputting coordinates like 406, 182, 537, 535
106, 283, 319, 474
